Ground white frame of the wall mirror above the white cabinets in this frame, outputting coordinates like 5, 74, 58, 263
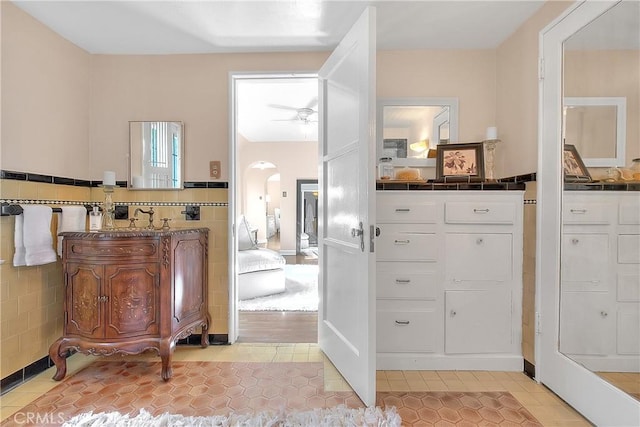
376, 97, 459, 167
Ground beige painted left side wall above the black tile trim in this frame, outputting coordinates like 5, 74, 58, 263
0, 1, 91, 179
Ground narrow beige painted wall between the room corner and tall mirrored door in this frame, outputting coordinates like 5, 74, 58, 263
495, 1, 573, 177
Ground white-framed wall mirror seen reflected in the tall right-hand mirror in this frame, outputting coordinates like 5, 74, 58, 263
562, 96, 627, 167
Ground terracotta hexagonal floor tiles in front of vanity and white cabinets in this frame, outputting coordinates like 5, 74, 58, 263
2, 357, 541, 426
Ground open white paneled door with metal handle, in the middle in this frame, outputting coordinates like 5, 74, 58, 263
318, 8, 376, 406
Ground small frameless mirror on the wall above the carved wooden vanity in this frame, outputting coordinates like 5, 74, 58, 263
129, 122, 184, 190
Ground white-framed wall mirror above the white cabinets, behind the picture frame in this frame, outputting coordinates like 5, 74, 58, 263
377, 98, 458, 167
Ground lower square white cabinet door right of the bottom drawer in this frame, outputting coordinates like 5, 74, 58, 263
444, 289, 513, 354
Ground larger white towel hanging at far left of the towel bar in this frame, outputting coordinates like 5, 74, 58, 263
13, 205, 57, 267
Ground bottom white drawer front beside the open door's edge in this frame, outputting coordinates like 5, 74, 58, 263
376, 310, 436, 353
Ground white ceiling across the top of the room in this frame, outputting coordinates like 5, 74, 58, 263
13, 0, 544, 54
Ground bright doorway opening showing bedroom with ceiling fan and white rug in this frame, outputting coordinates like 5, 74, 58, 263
230, 74, 319, 343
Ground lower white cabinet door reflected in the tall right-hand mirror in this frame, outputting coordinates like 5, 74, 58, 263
560, 292, 616, 355
